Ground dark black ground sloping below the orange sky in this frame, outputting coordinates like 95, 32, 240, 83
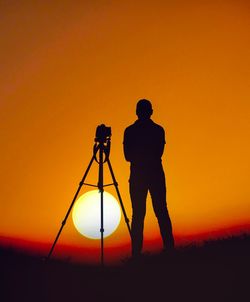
0, 235, 250, 302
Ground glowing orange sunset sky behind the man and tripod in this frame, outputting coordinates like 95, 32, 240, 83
0, 0, 250, 260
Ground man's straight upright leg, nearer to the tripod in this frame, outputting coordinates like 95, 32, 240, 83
129, 180, 148, 257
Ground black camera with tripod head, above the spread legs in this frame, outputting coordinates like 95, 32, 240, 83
93, 124, 111, 163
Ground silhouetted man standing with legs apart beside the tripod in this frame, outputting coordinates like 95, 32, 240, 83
123, 99, 174, 257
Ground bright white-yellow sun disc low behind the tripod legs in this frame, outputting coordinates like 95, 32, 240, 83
72, 190, 121, 239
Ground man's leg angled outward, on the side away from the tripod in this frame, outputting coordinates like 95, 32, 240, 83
149, 170, 174, 250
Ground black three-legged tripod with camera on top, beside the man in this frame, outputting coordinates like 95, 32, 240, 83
47, 125, 131, 265
